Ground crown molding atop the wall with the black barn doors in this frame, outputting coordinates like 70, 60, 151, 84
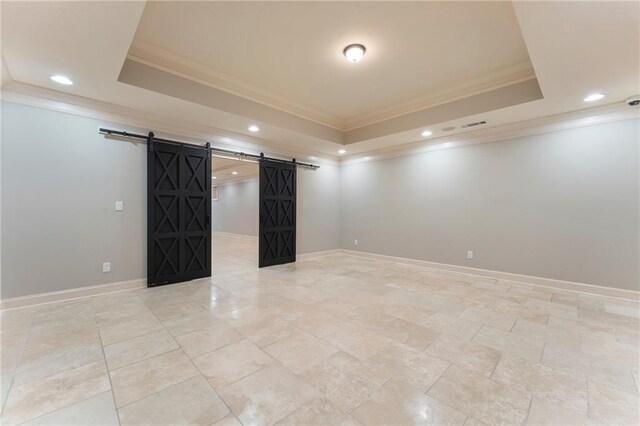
0, 81, 338, 165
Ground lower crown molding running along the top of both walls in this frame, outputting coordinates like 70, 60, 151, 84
0, 82, 640, 165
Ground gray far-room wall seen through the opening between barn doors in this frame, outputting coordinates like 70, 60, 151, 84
211, 179, 260, 237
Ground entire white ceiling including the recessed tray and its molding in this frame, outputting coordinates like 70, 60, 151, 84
0, 1, 640, 158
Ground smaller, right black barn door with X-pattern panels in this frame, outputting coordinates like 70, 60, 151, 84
258, 159, 296, 268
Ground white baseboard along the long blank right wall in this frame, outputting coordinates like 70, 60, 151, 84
339, 249, 640, 302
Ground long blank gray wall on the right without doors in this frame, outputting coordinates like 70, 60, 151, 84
341, 119, 640, 290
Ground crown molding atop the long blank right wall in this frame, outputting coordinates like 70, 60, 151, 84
340, 102, 640, 165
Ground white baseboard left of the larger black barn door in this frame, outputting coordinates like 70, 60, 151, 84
0, 278, 147, 311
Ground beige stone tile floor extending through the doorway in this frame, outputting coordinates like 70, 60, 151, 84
1, 237, 640, 425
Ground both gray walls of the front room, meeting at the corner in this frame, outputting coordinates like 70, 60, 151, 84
1, 102, 640, 298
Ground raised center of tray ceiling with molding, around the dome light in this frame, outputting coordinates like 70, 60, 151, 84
129, 2, 534, 131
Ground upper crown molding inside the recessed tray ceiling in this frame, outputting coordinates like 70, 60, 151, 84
127, 39, 536, 132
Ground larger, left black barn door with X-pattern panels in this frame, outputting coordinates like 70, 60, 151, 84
147, 134, 211, 287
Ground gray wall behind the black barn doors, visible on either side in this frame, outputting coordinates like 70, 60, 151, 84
0, 102, 340, 299
